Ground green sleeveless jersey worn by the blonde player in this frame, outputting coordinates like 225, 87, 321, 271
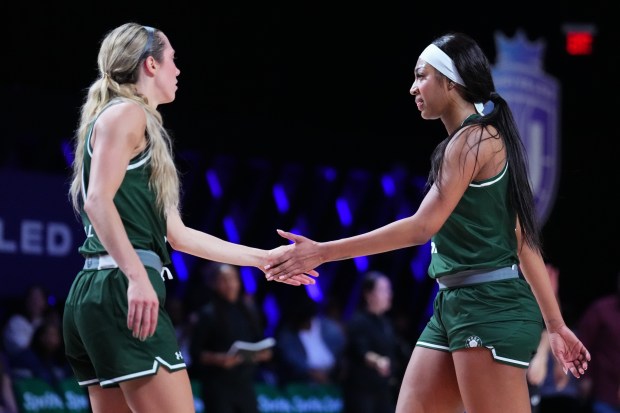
78, 100, 170, 265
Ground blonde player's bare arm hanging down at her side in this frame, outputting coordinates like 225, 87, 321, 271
84, 103, 159, 340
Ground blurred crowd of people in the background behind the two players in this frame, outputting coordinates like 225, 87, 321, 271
0, 261, 620, 413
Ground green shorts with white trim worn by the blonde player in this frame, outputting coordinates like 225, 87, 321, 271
63, 266, 187, 387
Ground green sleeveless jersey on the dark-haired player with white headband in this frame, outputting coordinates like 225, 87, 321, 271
428, 159, 519, 278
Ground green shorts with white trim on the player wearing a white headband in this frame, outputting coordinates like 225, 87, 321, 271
416, 278, 544, 368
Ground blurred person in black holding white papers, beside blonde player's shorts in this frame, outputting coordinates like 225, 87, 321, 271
190, 262, 273, 413
